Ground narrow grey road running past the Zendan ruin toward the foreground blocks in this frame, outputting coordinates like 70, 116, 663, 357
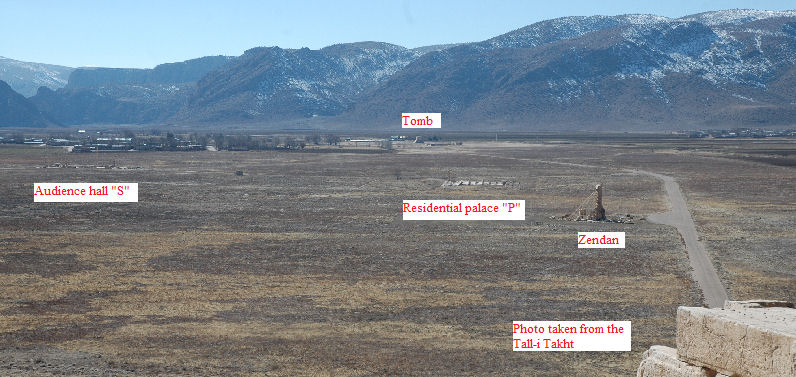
631, 170, 728, 308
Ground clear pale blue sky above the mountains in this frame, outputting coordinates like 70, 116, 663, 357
0, 0, 796, 68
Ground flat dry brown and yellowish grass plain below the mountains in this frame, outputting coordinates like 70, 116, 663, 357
0, 137, 796, 376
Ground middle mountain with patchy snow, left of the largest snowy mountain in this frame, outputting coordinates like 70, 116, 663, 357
177, 42, 436, 121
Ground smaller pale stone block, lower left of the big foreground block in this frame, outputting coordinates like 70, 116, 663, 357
636, 346, 716, 377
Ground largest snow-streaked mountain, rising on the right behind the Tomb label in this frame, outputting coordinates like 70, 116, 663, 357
347, 10, 796, 130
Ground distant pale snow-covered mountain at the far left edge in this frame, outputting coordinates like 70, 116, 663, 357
0, 56, 74, 97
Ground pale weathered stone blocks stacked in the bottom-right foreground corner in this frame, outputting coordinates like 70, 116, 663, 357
636, 300, 796, 377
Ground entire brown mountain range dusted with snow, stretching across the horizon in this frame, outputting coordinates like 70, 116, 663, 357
0, 10, 796, 131
